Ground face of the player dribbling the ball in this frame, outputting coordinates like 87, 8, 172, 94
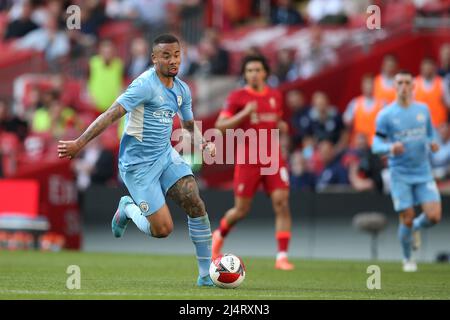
152, 42, 181, 77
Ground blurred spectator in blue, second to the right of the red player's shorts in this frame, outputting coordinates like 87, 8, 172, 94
316, 139, 349, 192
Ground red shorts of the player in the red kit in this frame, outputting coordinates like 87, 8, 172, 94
233, 163, 289, 198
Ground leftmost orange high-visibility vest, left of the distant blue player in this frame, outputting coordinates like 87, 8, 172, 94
351, 96, 384, 145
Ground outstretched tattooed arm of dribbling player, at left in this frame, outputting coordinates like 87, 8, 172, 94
58, 102, 126, 159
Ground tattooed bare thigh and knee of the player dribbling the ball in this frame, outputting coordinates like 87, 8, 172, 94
167, 176, 206, 218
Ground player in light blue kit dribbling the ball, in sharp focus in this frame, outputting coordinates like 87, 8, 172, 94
58, 35, 215, 286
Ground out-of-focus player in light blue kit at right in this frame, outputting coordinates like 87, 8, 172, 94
372, 71, 442, 272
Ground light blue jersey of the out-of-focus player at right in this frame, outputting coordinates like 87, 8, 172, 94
372, 101, 435, 183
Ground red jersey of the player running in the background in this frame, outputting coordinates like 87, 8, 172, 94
221, 86, 283, 164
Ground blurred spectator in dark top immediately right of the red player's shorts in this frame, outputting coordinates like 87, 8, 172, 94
289, 151, 316, 191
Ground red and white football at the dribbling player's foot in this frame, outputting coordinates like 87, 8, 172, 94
209, 253, 245, 289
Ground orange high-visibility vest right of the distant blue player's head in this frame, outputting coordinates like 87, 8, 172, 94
414, 76, 448, 127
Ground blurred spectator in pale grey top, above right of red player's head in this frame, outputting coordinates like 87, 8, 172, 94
289, 27, 338, 80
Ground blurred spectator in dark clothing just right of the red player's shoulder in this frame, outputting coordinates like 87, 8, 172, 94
286, 90, 309, 148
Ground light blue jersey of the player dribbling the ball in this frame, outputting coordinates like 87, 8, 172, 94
116, 68, 193, 171
